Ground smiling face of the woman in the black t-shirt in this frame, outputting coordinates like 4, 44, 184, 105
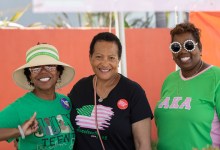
90, 40, 119, 80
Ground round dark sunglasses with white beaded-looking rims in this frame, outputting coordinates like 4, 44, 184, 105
170, 40, 198, 53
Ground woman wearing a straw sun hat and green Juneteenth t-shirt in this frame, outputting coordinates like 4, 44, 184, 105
0, 44, 75, 150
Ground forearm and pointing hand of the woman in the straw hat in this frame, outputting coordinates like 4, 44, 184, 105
0, 113, 38, 141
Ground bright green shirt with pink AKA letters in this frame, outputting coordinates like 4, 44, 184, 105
155, 66, 220, 150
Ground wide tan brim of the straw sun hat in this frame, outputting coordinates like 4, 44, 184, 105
12, 56, 75, 90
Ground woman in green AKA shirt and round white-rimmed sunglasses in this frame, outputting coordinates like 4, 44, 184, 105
155, 23, 220, 150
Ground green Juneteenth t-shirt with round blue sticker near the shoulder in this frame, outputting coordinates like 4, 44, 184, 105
0, 92, 75, 150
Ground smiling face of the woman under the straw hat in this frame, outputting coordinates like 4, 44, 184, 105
30, 65, 60, 91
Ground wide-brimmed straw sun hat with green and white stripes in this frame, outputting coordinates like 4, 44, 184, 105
13, 44, 75, 90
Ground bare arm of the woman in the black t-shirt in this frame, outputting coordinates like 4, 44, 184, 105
132, 118, 151, 150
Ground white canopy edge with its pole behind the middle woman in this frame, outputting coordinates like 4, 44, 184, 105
33, 0, 220, 76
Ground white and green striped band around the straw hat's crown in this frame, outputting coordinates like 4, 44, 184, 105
26, 50, 59, 63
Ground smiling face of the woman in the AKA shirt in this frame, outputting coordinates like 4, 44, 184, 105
173, 32, 201, 72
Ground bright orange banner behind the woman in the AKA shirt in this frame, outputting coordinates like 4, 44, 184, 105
190, 12, 220, 66
